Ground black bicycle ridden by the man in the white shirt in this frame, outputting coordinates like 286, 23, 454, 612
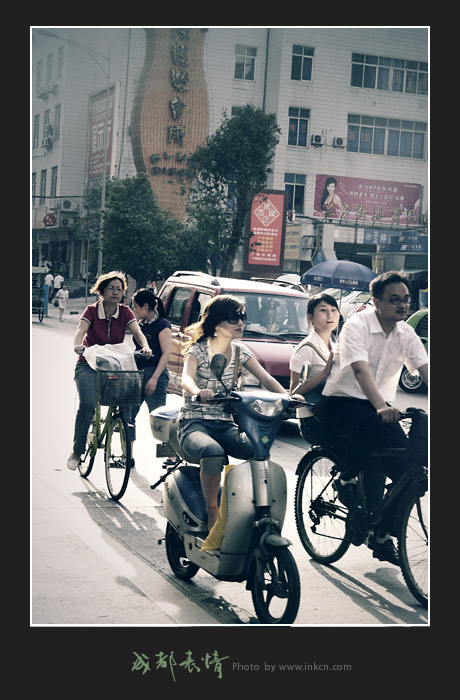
294, 408, 428, 607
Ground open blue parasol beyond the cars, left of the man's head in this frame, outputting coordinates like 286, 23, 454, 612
300, 260, 376, 290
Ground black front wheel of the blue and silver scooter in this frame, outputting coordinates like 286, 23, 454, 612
251, 547, 300, 625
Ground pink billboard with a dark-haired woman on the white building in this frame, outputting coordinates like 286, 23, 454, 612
313, 175, 422, 226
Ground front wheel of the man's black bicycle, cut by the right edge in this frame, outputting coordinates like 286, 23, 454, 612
398, 486, 428, 607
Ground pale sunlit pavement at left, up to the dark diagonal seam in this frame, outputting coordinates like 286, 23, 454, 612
30, 296, 218, 627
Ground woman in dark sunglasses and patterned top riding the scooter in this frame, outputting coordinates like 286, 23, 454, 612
178, 295, 287, 530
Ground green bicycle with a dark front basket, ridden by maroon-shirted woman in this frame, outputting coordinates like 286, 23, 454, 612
78, 353, 144, 501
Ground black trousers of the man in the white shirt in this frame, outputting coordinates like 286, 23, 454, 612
321, 396, 408, 523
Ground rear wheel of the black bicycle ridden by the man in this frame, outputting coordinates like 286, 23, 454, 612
294, 447, 350, 564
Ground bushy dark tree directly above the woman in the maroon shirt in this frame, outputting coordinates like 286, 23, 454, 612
103, 173, 183, 288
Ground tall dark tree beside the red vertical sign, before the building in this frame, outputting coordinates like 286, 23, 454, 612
187, 105, 281, 276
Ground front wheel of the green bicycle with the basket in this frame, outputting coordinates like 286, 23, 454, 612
104, 409, 131, 501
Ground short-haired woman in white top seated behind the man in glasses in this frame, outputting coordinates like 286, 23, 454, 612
289, 292, 340, 446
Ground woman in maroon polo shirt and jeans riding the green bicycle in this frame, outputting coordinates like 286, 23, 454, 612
67, 271, 152, 471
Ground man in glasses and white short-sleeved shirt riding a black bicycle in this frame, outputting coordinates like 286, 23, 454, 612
313, 272, 428, 564
